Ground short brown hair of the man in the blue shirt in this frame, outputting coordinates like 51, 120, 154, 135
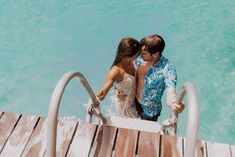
140, 34, 165, 55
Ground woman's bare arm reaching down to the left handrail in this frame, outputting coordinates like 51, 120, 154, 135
96, 67, 120, 100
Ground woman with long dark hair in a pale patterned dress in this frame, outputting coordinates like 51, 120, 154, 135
97, 37, 140, 118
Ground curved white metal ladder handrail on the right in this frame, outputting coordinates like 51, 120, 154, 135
176, 83, 198, 157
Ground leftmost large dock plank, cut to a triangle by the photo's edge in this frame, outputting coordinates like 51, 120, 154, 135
0, 112, 20, 152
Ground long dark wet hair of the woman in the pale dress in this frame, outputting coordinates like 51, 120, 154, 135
111, 37, 141, 68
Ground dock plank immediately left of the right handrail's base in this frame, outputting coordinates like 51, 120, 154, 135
161, 135, 183, 157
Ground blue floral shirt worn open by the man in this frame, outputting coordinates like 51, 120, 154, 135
135, 56, 177, 117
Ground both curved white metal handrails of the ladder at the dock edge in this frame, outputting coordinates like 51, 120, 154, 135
47, 71, 198, 157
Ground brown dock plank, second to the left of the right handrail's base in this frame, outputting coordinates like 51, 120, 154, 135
137, 132, 160, 157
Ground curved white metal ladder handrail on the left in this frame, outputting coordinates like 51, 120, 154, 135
47, 71, 98, 157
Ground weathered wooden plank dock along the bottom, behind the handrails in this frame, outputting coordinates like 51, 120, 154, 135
0, 111, 235, 157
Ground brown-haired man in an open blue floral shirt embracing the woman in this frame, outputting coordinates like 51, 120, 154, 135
119, 34, 184, 121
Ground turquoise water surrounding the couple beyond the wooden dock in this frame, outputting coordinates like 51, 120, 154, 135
0, 0, 235, 144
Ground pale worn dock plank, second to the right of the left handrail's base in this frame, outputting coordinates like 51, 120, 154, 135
67, 123, 97, 157
